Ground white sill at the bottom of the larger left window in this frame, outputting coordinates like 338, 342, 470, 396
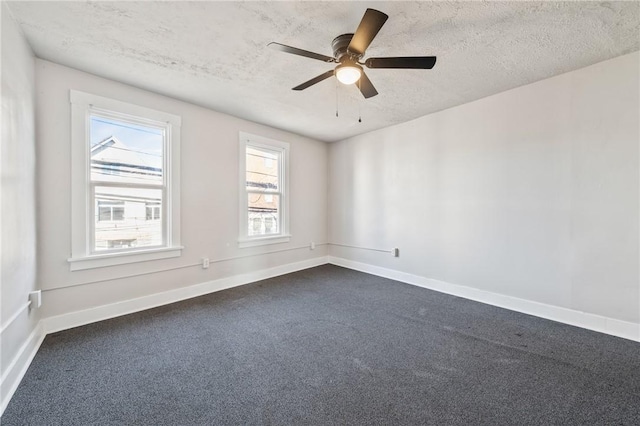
67, 246, 184, 271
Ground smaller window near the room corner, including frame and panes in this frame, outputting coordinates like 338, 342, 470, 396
239, 133, 291, 247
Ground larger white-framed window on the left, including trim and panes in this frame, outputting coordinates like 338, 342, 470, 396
69, 90, 182, 271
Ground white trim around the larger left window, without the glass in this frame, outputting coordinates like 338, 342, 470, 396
67, 90, 184, 271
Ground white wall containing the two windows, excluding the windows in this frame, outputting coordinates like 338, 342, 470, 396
36, 59, 328, 317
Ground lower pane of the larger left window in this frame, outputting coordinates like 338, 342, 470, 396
94, 186, 163, 251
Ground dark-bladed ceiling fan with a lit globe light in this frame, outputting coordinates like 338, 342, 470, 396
268, 9, 436, 98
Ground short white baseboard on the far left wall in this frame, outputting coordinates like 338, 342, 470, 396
0, 322, 46, 416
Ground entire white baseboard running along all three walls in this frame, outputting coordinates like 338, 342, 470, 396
0, 256, 640, 415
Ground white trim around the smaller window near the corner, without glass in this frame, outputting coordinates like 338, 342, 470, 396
238, 132, 291, 248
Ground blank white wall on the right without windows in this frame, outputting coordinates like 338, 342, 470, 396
329, 52, 640, 323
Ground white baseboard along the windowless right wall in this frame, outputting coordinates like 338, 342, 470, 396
328, 256, 640, 342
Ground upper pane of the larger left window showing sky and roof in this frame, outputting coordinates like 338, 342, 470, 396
90, 115, 164, 185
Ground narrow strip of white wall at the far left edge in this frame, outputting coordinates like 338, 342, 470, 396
0, 2, 39, 412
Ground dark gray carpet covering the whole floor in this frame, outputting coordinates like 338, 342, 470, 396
1, 265, 640, 426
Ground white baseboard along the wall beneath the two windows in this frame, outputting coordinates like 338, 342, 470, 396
42, 256, 328, 334
